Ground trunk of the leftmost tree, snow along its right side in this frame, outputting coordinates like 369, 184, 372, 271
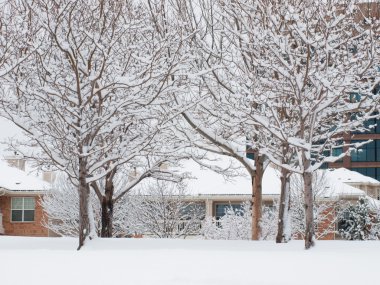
78, 157, 91, 250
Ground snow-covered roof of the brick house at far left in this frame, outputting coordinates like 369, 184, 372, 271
0, 160, 51, 191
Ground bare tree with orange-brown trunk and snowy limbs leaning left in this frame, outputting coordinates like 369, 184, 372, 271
167, 0, 267, 239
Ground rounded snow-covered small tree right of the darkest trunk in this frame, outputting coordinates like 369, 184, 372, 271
120, 180, 205, 238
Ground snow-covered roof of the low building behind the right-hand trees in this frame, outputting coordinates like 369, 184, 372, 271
183, 160, 371, 198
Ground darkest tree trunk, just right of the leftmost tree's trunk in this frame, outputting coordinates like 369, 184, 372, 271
100, 179, 114, 238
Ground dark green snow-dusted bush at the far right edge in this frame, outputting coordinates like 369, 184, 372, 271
338, 198, 380, 240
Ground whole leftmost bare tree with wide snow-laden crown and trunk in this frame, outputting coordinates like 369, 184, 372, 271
2, 0, 189, 248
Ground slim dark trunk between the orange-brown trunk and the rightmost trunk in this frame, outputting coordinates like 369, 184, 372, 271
276, 168, 290, 243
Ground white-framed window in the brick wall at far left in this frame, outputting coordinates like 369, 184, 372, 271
11, 197, 36, 222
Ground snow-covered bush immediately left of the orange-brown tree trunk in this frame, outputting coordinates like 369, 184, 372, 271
201, 202, 252, 240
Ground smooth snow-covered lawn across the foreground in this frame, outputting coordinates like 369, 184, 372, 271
0, 236, 380, 285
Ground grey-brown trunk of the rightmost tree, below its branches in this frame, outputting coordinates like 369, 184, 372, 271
303, 162, 314, 249
